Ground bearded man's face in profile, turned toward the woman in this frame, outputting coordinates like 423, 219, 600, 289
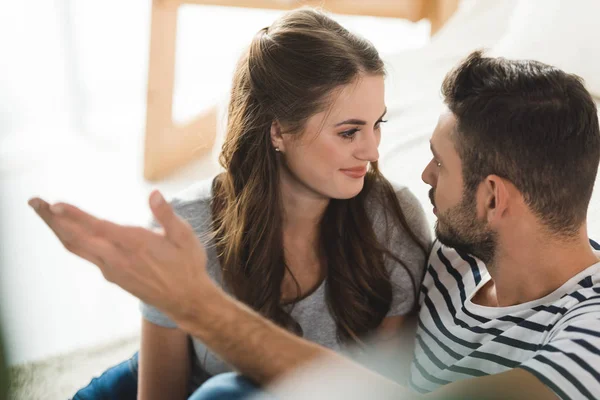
421, 110, 496, 264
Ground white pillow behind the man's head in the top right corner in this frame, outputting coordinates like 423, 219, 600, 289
489, 0, 600, 97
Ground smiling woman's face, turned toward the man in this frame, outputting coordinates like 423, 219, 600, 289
273, 75, 386, 199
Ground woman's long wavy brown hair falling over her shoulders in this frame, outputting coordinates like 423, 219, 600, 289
212, 9, 426, 343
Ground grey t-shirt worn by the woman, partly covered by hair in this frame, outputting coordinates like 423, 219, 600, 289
140, 179, 431, 384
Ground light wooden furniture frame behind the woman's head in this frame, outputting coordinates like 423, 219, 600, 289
144, 0, 460, 181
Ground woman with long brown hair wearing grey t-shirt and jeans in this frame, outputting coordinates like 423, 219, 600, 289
68, 9, 430, 399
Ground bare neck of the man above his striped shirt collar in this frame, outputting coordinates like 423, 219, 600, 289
488, 226, 600, 307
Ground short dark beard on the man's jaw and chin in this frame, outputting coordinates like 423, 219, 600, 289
429, 189, 497, 265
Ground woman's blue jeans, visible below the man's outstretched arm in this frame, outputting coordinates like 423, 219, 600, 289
73, 353, 260, 400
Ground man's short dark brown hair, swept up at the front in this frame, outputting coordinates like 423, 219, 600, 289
442, 51, 600, 236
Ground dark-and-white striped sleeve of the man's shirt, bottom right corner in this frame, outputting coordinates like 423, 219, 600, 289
520, 312, 600, 399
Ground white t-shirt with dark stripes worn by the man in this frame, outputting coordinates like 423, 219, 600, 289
410, 242, 600, 399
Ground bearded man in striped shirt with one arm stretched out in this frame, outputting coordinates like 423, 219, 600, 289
30, 52, 600, 399
